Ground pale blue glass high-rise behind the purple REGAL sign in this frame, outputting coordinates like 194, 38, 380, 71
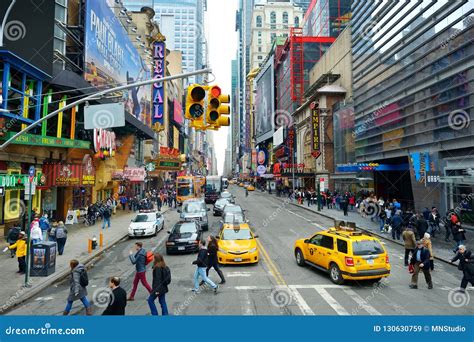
124, 0, 207, 83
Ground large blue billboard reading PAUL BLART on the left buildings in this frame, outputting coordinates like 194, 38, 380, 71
84, 0, 151, 126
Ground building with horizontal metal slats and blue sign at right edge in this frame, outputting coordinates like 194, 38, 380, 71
352, 0, 474, 219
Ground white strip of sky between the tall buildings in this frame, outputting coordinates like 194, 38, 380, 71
205, 0, 238, 175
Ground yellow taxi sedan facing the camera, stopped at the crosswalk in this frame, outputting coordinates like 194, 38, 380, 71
216, 212, 259, 265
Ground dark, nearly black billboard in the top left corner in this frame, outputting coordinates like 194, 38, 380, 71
0, 0, 55, 76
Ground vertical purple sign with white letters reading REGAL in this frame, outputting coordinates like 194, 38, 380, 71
152, 41, 166, 126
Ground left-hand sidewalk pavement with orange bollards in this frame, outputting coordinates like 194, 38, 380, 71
0, 208, 151, 314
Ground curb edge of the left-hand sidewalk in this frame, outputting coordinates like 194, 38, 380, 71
1, 208, 170, 315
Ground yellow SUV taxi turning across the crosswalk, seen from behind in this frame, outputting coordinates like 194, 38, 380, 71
294, 221, 390, 285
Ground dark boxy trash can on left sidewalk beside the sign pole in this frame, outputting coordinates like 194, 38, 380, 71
30, 241, 58, 277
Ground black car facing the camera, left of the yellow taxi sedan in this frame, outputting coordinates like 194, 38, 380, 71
166, 221, 202, 254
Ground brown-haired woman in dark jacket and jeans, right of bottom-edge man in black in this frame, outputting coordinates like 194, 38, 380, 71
147, 253, 171, 316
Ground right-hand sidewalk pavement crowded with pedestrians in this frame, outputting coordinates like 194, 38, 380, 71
264, 195, 469, 262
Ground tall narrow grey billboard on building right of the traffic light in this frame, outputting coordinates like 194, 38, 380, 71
255, 58, 275, 144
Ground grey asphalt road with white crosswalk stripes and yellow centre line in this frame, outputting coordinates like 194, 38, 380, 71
9, 186, 474, 315
